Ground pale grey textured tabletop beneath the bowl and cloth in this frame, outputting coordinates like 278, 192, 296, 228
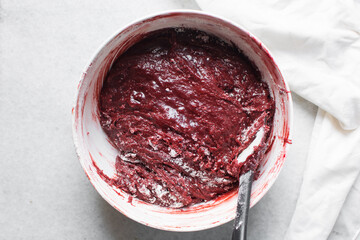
0, 0, 316, 240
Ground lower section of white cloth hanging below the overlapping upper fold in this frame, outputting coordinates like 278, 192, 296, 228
285, 109, 360, 240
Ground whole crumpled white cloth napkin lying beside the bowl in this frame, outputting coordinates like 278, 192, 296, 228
197, 0, 360, 240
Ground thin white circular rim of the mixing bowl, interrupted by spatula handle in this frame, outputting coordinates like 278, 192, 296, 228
71, 9, 293, 232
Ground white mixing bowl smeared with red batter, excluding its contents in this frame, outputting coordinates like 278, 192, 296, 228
72, 10, 292, 231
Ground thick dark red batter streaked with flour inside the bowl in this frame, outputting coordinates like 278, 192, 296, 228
100, 28, 275, 208
